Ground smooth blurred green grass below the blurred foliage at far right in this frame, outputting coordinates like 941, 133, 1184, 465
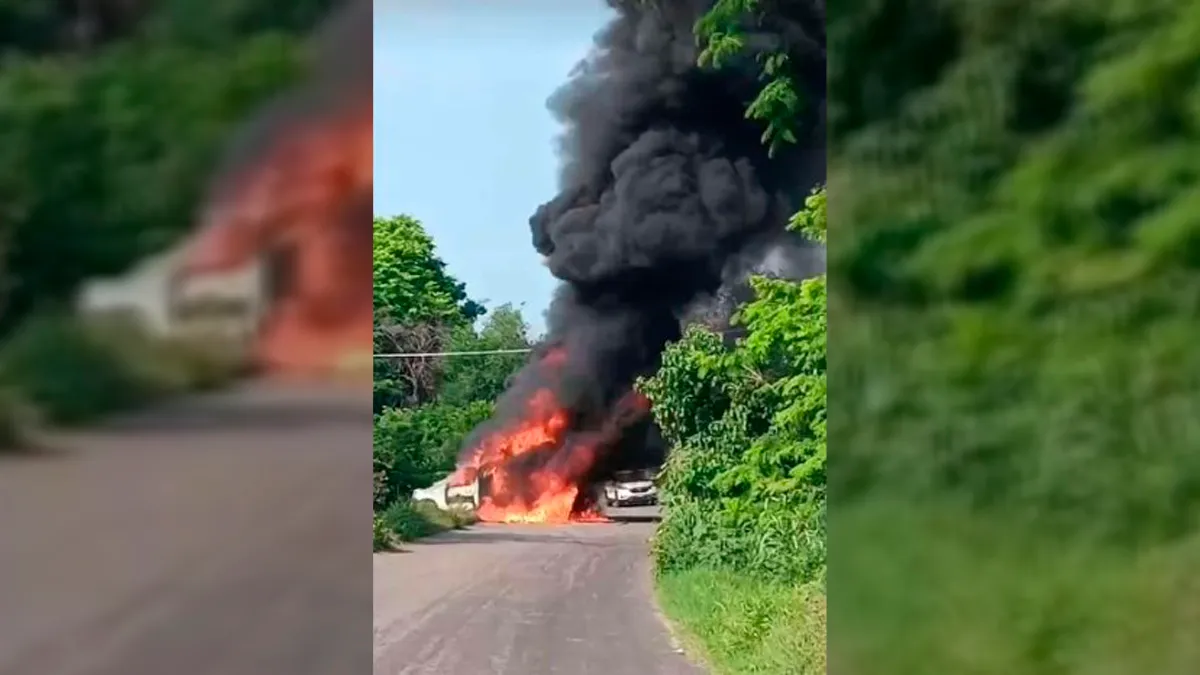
829, 502, 1200, 675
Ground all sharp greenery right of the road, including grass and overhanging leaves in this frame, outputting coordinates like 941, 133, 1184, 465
640, 1, 827, 675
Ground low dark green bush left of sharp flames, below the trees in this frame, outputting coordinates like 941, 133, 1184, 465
374, 401, 492, 509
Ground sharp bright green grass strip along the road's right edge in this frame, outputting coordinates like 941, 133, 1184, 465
658, 569, 826, 675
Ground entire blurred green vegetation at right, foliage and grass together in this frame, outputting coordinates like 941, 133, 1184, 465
828, 0, 1200, 675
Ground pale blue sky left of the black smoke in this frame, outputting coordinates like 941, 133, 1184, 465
374, 0, 608, 331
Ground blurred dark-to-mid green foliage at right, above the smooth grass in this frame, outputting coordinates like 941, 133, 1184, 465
830, 1, 1200, 540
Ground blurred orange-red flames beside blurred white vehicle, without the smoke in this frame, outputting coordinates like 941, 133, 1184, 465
181, 98, 373, 376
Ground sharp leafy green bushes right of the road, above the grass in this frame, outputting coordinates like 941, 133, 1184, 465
641, 186, 826, 580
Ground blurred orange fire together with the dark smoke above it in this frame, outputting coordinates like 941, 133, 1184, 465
181, 0, 373, 377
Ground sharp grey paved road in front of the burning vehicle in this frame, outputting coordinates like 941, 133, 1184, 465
374, 506, 702, 675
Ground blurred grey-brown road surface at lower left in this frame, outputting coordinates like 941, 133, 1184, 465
0, 384, 371, 675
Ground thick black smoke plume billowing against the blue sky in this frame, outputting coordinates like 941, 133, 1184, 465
462, 0, 826, 494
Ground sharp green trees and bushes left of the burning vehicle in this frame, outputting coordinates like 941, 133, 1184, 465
374, 216, 532, 550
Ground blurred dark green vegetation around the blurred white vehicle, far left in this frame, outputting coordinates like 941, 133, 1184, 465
0, 0, 332, 449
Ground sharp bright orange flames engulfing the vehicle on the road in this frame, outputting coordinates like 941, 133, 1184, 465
451, 350, 647, 524
